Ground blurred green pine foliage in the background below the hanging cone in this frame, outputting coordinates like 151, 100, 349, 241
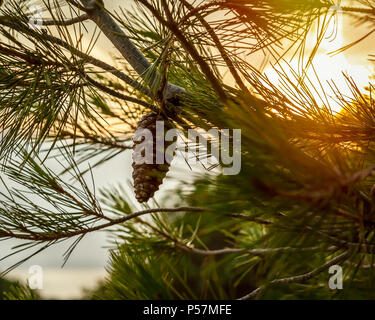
94, 176, 346, 299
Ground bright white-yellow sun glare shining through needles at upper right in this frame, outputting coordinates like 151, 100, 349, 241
264, 10, 373, 113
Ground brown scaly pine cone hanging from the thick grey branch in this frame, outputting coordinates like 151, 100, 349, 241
132, 112, 172, 203
